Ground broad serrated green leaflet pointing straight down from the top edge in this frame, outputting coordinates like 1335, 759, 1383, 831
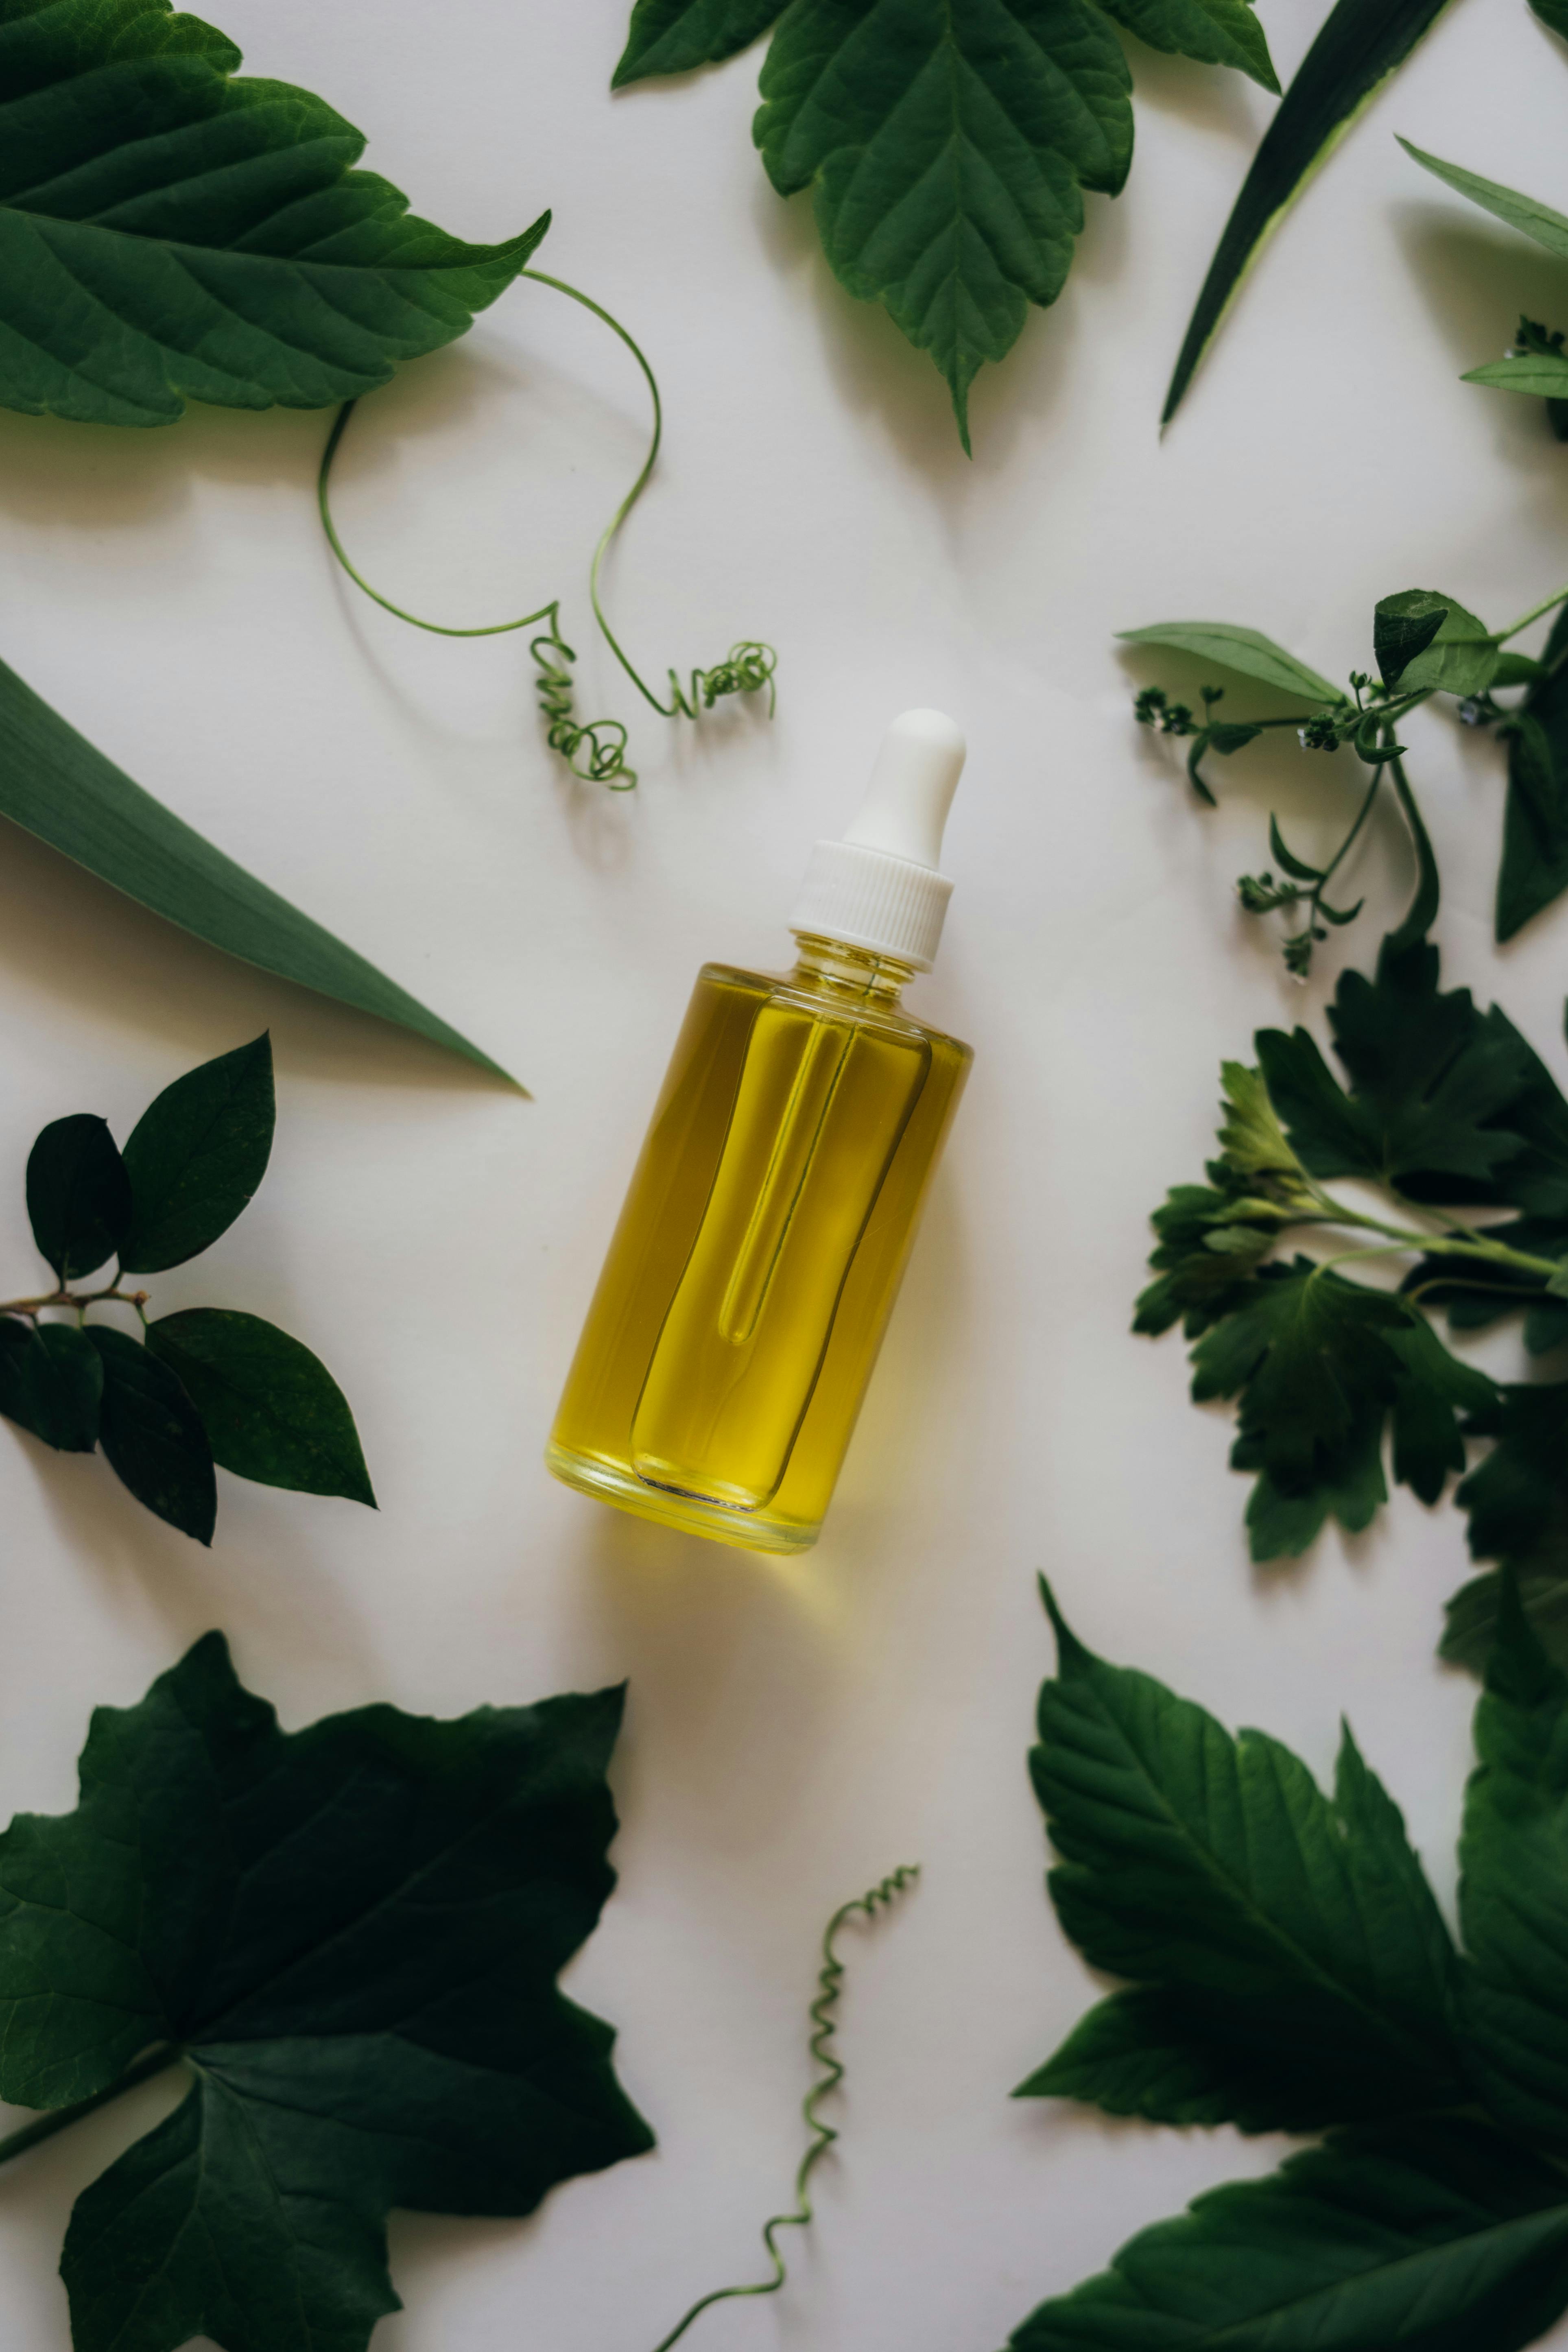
752, 0, 1133, 449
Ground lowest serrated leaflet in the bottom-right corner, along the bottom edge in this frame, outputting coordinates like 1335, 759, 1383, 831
1011, 2121, 1568, 2352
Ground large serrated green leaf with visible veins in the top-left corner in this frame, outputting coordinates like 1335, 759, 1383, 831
0, 0, 550, 426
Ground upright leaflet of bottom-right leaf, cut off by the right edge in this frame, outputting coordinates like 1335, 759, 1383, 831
1460, 1581, 1568, 2140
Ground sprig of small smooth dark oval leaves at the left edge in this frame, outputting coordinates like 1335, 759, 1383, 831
0, 1037, 376, 1543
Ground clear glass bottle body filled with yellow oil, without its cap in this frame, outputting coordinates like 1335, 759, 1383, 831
546, 936, 971, 1552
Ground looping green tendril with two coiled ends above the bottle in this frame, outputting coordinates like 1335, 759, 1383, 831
315, 271, 778, 793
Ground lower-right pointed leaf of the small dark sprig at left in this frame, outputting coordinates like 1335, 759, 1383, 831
148, 1308, 376, 1510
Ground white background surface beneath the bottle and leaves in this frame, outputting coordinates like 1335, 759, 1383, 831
0, 0, 1568, 2352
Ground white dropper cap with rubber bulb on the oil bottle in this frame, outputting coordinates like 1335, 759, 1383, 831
790, 710, 964, 972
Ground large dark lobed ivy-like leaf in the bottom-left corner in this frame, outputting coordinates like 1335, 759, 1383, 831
0, 1635, 651, 2352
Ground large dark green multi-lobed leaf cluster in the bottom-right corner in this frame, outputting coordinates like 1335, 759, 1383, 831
1011, 1588, 1568, 2352
